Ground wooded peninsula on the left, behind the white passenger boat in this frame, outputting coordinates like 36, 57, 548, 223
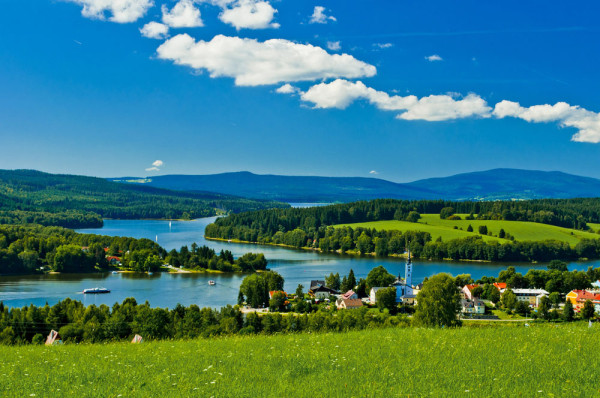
0, 225, 267, 275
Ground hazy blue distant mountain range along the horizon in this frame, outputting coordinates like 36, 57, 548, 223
110, 169, 600, 203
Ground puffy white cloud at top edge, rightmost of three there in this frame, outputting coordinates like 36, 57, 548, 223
219, 0, 279, 30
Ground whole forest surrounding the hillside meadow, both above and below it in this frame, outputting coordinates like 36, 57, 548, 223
205, 199, 600, 261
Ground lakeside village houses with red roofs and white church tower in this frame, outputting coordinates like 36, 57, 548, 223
255, 254, 600, 320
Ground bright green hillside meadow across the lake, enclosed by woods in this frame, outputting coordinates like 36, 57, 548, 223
336, 214, 600, 245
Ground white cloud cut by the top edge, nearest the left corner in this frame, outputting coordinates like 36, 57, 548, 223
67, 0, 154, 23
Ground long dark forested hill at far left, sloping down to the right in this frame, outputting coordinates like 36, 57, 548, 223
0, 170, 288, 228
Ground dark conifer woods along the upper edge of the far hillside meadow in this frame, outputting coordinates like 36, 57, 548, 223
206, 198, 600, 238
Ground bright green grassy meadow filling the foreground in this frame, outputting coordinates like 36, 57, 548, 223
0, 322, 600, 398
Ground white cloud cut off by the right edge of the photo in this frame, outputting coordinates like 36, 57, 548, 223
493, 100, 600, 144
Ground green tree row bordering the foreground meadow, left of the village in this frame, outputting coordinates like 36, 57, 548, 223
0, 298, 408, 344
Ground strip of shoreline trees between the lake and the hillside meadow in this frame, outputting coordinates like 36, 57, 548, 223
205, 212, 600, 262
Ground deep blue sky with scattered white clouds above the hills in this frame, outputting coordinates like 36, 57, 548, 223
0, 0, 600, 181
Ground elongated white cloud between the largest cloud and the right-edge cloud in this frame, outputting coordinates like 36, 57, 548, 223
301, 79, 492, 121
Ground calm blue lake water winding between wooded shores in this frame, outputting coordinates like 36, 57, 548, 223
0, 217, 600, 308
